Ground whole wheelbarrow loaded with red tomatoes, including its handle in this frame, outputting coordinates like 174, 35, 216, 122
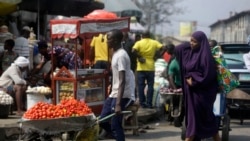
20, 99, 131, 141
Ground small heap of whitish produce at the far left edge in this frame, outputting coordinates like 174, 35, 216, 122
0, 91, 13, 118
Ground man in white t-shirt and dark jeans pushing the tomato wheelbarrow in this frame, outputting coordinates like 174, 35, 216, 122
100, 30, 135, 141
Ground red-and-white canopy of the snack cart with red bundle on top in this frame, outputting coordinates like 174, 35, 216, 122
50, 10, 130, 38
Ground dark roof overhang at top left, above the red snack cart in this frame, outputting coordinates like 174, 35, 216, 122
19, 0, 104, 17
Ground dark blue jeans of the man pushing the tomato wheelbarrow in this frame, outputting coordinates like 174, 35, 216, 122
100, 97, 133, 141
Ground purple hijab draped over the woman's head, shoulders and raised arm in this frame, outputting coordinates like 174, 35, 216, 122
175, 31, 216, 85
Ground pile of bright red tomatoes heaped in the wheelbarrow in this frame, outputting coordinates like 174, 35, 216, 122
23, 98, 92, 120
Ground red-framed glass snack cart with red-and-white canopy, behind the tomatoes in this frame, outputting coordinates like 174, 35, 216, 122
50, 10, 130, 114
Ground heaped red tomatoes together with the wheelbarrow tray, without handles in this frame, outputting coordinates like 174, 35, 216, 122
21, 98, 95, 138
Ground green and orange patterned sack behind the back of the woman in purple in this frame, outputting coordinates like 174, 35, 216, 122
215, 56, 240, 94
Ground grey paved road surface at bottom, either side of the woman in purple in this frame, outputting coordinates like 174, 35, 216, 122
107, 120, 250, 141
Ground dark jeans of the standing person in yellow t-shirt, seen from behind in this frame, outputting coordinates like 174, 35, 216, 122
137, 71, 155, 107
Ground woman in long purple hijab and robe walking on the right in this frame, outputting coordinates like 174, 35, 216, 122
175, 31, 220, 141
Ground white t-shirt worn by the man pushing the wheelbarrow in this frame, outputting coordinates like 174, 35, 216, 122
109, 48, 135, 100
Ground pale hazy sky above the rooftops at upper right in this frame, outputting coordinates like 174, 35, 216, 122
158, 0, 250, 35
